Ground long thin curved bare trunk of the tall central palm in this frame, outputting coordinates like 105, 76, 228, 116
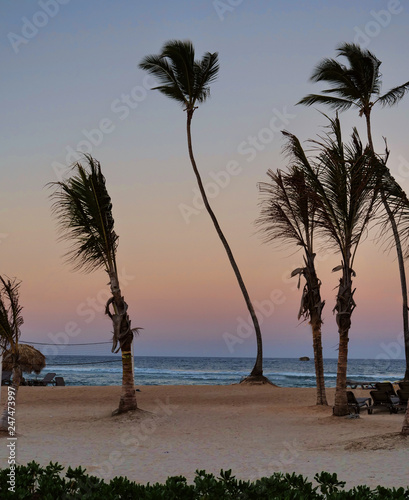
186, 109, 267, 382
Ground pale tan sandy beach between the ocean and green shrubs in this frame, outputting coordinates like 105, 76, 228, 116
0, 385, 409, 487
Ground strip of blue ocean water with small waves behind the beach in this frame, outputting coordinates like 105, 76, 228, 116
27, 355, 405, 387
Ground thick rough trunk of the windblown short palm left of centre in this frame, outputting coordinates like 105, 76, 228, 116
106, 271, 138, 415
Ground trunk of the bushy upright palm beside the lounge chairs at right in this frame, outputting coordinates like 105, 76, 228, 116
333, 264, 355, 417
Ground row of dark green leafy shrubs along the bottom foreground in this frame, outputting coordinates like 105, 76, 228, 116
0, 462, 409, 500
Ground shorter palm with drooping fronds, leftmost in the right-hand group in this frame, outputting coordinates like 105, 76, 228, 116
256, 170, 328, 405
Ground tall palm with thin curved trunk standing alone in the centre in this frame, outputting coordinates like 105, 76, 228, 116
139, 40, 268, 383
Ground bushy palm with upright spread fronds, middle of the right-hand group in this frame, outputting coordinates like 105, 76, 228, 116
284, 117, 381, 416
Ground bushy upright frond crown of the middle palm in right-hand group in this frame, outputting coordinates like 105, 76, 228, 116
285, 117, 380, 262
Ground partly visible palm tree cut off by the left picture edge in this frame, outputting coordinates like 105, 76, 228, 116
0, 276, 24, 431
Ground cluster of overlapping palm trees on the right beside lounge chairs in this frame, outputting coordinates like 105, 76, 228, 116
257, 43, 409, 433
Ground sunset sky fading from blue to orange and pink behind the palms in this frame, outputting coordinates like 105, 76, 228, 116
0, 0, 409, 357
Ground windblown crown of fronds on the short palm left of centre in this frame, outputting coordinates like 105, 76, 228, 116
50, 155, 118, 272
